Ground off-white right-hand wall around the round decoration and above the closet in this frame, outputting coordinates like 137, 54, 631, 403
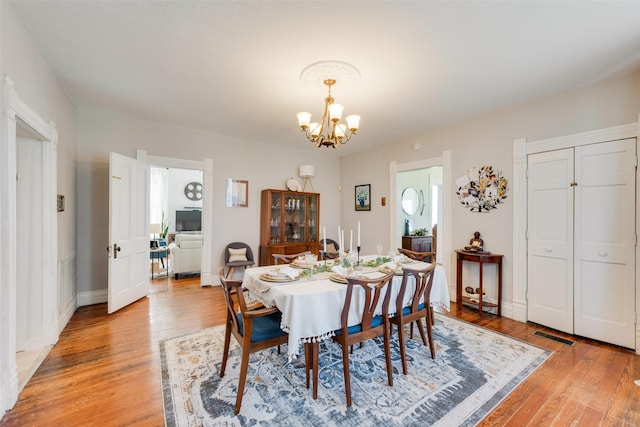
341, 72, 640, 314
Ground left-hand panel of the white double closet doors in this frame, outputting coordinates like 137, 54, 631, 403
527, 149, 573, 333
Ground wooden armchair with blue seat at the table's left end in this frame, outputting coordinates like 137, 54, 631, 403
218, 267, 288, 415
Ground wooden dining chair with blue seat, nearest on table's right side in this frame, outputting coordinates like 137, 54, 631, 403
305, 273, 393, 407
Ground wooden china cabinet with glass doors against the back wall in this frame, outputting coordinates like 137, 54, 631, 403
260, 190, 320, 265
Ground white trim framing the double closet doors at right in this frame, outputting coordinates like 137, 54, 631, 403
511, 114, 640, 354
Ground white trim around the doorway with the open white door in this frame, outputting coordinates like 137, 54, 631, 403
137, 150, 218, 286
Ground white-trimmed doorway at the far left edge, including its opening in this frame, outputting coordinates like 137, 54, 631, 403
0, 77, 58, 411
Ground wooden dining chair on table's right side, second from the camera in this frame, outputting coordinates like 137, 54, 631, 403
389, 263, 436, 375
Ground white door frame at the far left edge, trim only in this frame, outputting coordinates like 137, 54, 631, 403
0, 77, 58, 413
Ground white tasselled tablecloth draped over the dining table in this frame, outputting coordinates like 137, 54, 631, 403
244, 257, 449, 358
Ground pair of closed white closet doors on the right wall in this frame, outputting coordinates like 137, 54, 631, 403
527, 139, 636, 348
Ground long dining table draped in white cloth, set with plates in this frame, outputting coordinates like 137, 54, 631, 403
243, 255, 450, 360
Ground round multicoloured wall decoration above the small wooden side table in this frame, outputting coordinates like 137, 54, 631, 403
456, 166, 507, 212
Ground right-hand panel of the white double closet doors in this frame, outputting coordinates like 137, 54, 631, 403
574, 139, 636, 348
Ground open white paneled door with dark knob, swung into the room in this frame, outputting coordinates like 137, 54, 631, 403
108, 153, 149, 313
